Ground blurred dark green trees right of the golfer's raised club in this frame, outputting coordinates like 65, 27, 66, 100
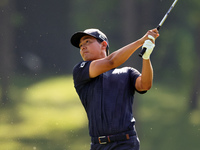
150, 0, 200, 109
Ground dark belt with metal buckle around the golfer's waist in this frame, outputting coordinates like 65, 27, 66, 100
91, 130, 136, 144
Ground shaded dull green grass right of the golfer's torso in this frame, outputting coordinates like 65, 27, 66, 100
138, 85, 200, 150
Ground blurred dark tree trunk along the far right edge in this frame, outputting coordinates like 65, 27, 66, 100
187, 0, 200, 110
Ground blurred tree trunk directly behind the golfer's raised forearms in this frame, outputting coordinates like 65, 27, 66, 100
119, 0, 142, 68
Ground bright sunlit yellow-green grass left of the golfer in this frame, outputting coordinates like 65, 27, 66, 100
0, 76, 89, 150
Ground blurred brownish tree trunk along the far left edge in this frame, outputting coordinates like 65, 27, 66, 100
0, 0, 14, 105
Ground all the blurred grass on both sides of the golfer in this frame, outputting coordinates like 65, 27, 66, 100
0, 76, 200, 150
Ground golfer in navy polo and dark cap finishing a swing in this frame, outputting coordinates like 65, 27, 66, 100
71, 29, 159, 150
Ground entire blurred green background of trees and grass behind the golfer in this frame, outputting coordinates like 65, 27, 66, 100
0, 0, 200, 150
